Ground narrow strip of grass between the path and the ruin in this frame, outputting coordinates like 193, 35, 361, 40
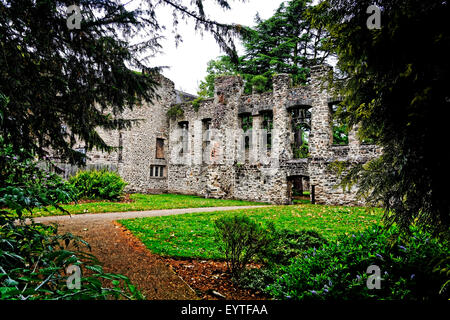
27, 194, 262, 217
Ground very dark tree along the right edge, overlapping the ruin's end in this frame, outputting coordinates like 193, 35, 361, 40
320, 0, 450, 233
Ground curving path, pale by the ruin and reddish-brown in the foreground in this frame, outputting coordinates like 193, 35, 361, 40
33, 206, 266, 300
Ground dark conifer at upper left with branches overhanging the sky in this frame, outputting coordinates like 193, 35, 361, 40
0, 0, 243, 163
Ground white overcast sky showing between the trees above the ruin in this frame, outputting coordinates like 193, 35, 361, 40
151, 0, 284, 94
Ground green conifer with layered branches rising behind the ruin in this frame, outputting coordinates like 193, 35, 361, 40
240, 0, 329, 83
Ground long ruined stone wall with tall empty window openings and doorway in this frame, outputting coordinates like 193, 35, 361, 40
168, 65, 379, 205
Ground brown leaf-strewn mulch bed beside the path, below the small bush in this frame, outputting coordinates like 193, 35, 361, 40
161, 257, 270, 300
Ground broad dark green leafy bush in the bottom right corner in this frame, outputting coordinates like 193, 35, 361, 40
268, 226, 450, 300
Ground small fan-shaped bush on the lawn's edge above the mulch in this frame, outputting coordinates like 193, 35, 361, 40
215, 215, 271, 278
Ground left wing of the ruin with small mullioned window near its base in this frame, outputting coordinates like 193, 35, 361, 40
79, 76, 176, 193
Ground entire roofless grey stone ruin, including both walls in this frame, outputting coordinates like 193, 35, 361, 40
67, 65, 380, 205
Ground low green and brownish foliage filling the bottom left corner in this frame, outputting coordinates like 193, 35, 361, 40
0, 212, 143, 300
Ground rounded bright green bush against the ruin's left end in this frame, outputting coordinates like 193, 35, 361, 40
69, 170, 127, 200
